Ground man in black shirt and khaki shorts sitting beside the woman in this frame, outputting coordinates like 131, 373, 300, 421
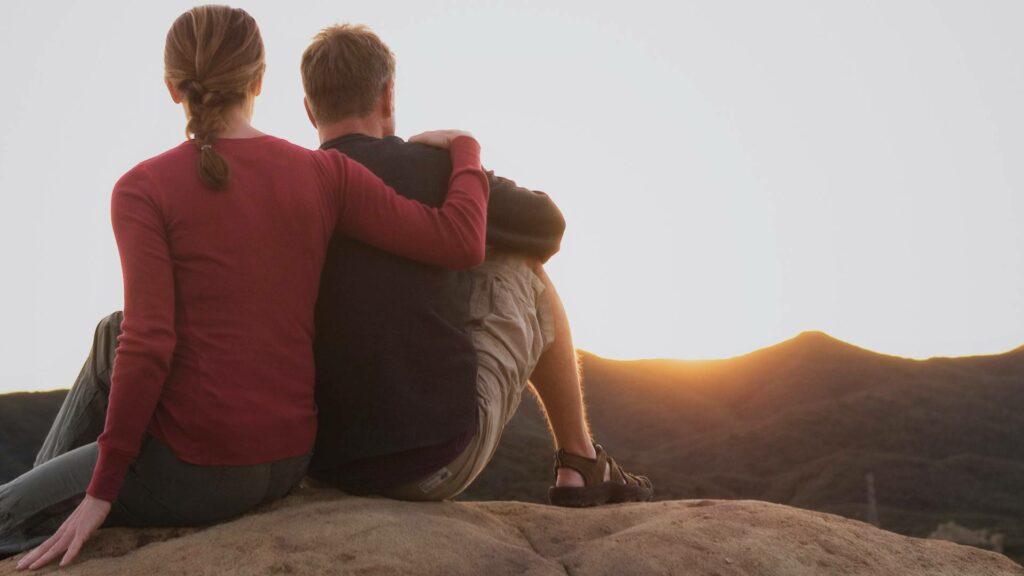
302, 26, 651, 506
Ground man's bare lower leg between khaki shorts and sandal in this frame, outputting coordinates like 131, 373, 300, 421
529, 262, 597, 486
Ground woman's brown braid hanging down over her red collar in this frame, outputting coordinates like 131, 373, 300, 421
178, 80, 245, 190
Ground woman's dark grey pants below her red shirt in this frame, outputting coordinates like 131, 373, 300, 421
0, 313, 309, 558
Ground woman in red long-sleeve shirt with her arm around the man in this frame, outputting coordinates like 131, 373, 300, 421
0, 6, 487, 569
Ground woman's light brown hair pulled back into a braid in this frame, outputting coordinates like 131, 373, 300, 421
164, 6, 265, 190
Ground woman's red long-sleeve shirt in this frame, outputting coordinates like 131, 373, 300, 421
88, 136, 487, 501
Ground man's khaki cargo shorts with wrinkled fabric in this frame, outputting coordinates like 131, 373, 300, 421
386, 252, 554, 500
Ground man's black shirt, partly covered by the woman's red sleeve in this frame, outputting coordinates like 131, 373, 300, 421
310, 134, 565, 485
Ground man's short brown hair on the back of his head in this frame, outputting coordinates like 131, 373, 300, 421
302, 24, 394, 124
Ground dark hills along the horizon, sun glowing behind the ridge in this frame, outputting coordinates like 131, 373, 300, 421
0, 332, 1024, 561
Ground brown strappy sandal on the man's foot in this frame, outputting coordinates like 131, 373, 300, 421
548, 444, 654, 507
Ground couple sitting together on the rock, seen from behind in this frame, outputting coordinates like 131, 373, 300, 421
0, 6, 651, 568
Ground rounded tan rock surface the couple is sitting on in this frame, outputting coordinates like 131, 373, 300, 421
0, 489, 1024, 576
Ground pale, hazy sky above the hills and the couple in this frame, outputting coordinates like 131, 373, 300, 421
0, 0, 1024, 393
